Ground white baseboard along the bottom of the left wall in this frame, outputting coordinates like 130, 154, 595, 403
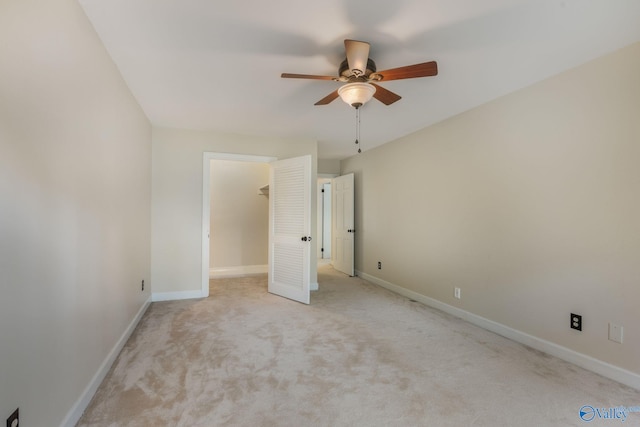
60, 298, 151, 427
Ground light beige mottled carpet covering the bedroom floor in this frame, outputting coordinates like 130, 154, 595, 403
78, 266, 640, 427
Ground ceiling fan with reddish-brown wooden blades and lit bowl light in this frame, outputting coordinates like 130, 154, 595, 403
281, 40, 438, 109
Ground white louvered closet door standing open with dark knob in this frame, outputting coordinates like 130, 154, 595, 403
268, 156, 311, 304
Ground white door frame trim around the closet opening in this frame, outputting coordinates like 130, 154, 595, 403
201, 151, 278, 298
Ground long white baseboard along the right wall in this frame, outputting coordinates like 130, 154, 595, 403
356, 271, 640, 390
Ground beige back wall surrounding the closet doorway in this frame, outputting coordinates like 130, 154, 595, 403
151, 127, 317, 296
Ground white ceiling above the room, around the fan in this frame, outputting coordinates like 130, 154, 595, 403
79, 0, 640, 159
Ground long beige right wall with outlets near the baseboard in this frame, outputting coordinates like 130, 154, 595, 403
342, 43, 640, 373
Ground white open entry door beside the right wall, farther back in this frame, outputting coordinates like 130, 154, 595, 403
331, 173, 355, 276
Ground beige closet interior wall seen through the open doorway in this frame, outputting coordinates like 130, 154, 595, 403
209, 160, 269, 269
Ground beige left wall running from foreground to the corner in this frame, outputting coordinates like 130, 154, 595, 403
0, 0, 151, 427
